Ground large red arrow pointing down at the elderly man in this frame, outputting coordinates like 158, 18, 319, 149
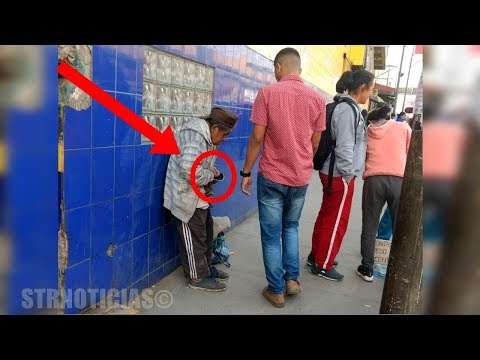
57, 61, 180, 154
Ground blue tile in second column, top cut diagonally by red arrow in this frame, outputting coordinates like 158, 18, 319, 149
92, 97, 115, 147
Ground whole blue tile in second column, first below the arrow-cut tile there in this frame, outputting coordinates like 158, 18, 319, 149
91, 147, 115, 203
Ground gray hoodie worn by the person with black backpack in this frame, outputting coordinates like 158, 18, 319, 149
321, 94, 367, 181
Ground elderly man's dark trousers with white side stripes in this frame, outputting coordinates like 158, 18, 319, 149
172, 209, 213, 279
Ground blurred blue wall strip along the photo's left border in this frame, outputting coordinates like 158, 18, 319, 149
5, 46, 58, 314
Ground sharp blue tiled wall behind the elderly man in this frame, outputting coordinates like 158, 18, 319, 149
64, 45, 274, 313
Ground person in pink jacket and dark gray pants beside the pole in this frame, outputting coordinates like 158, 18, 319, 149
357, 106, 412, 281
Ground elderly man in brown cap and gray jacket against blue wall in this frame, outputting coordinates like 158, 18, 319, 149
163, 107, 238, 291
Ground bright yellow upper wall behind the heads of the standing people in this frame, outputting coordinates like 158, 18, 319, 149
247, 45, 366, 95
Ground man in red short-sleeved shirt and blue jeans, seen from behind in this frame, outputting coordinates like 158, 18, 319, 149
240, 48, 325, 307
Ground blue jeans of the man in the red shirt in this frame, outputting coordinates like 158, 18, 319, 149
257, 173, 308, 294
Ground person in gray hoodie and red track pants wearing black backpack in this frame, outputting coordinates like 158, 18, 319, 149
307, 70, 375, 281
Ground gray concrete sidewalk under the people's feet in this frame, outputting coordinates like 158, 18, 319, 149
140, 171, 384, 315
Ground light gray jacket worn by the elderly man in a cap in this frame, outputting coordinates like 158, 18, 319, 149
163, 118, 216, 223
